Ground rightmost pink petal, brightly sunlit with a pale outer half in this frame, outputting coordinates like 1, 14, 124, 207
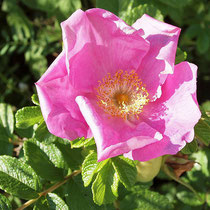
127, 62, 201, 161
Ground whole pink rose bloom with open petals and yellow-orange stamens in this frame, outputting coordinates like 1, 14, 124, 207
36, 9, 200, 161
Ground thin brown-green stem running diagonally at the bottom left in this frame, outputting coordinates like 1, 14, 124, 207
16, 170, 81, 210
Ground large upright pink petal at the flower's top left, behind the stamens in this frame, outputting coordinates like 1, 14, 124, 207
61, 9, 149, 92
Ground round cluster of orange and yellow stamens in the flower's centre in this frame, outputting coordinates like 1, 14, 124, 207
96, 70, 149, 119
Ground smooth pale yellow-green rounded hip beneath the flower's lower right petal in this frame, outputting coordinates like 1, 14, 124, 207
136, 157, 162, 182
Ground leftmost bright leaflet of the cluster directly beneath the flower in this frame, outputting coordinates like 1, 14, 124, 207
82, 152, 99, 187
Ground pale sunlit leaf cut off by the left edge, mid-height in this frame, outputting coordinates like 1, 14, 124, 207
0, 103, 14, 137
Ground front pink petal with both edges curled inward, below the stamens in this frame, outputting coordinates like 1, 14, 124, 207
76, 96, 162, 161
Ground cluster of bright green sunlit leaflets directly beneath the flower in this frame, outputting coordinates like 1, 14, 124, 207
82, 151, 137, 205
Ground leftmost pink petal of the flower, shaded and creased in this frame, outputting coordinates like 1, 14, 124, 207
36, 52, 89, 140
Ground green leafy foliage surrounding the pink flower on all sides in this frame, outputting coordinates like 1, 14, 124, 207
0, 0, 210, 210
